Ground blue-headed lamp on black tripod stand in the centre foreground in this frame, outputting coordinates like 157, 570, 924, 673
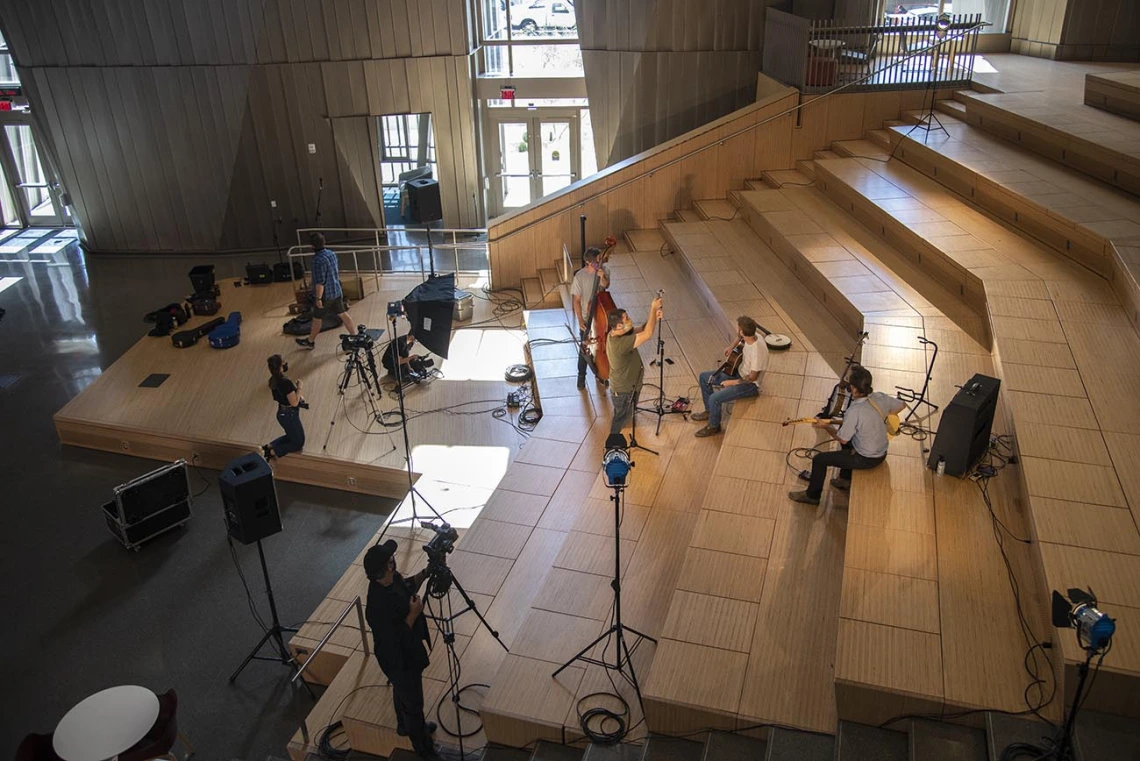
551, 434, 657, 714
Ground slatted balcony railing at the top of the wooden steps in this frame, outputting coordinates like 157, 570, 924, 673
764, 8, 985, 93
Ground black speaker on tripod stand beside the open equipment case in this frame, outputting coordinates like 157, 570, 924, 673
218, 453, 282, 545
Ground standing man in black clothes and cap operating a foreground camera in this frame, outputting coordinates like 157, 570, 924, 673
364, 539, 439, 759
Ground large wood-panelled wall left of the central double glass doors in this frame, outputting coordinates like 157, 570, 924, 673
0, 0, 481, 252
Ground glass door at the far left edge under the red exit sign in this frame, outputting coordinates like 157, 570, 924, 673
0, 122, 66, 227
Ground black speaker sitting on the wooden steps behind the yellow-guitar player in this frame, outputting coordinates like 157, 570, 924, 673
927, 375, 1001, 476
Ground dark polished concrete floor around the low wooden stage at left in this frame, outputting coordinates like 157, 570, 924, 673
0, 231, 401, 761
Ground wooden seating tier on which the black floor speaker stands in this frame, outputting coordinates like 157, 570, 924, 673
729, 184, 1048, 723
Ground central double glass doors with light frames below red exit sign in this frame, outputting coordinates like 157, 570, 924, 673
490, 109, 581, 216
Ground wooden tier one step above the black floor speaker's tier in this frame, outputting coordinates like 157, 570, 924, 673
820, 152, 1140, 715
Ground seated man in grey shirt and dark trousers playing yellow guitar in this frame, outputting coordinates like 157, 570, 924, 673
788, 365, 906, 505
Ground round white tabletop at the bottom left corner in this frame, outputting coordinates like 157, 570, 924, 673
51, 685, 158, 761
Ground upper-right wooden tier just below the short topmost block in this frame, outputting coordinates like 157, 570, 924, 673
966, 92, 1140, 194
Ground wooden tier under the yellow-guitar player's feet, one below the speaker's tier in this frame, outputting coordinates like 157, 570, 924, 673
642, 216, 847, 734
